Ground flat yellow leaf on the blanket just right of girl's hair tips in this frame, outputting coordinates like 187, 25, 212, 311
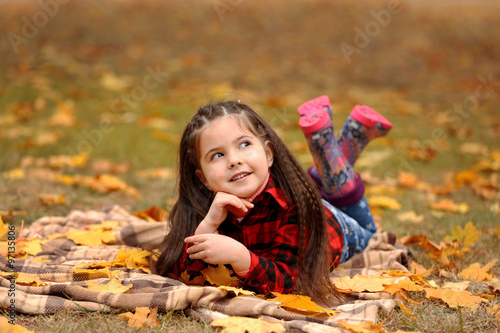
334, 274, 394, 294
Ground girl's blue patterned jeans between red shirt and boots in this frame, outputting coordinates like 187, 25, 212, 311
323, 197, 377, 263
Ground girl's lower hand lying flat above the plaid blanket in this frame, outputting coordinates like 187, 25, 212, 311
184, 234, 250, 271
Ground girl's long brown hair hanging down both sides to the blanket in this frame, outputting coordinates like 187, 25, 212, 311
152, 101, 343, 305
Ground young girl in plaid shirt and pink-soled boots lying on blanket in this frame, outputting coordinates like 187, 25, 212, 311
155, 96, 390, 305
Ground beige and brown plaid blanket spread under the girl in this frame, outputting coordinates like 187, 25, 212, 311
0, 205, 408, 332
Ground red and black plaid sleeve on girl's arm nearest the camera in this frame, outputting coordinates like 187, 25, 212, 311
240, 213, 299, 295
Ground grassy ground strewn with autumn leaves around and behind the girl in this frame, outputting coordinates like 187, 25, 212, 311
0, 0, 500, 332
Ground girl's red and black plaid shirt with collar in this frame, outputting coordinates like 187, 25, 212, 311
172, 177, 344, 295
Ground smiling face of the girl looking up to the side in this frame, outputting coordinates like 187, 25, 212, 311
196, 117, 273, 198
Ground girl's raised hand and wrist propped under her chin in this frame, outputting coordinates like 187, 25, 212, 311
195, 192, 253, 235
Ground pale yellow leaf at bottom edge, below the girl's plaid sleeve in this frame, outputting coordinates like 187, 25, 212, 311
210, 316, 285, 333
